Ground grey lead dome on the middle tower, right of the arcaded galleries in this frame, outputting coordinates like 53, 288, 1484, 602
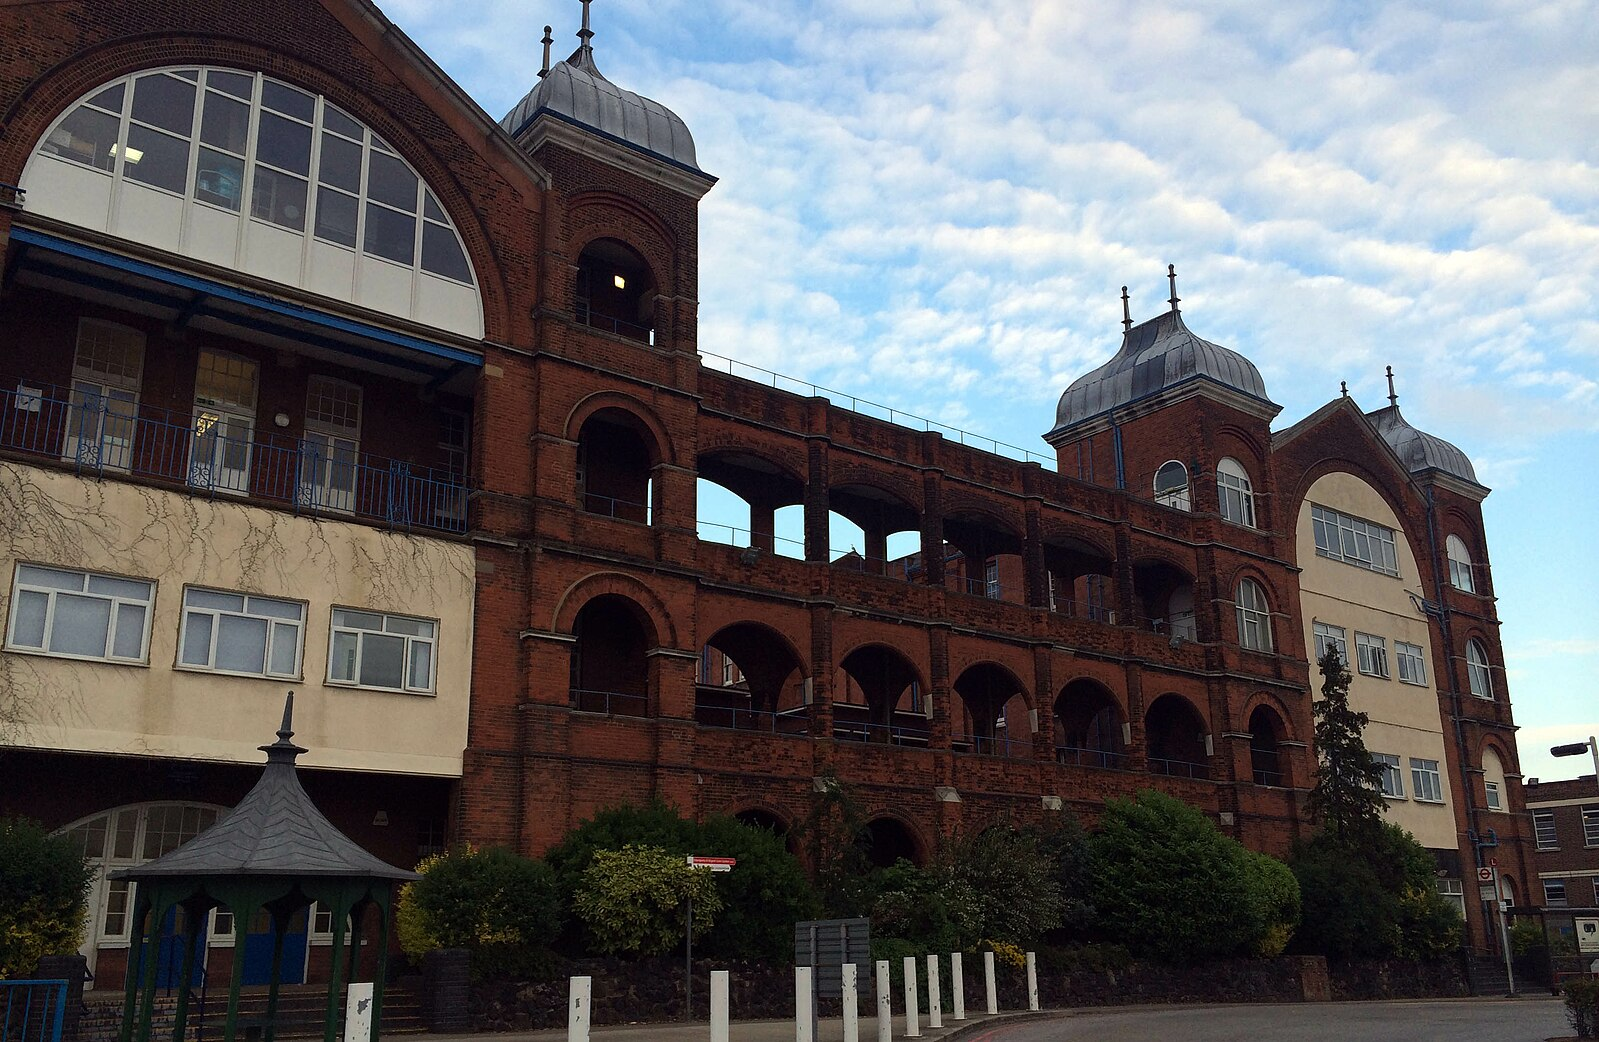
1046, 308, 1279, 438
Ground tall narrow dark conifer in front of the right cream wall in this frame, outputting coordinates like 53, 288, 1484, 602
1310, 646, 1388, 849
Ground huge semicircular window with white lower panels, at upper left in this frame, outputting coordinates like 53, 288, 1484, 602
22, 67, 483, 337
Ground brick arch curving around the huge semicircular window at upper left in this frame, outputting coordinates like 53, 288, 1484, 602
0, 34, 511, 340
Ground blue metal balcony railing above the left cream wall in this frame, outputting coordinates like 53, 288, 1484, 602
0, 384, 469, 532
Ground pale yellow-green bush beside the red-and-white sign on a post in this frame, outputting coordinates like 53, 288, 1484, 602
572, 844, 721, 956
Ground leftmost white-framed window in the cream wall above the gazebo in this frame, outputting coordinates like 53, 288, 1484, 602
6, 564, 155, 662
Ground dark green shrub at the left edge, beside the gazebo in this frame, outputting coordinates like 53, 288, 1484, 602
0, 818, 93, 978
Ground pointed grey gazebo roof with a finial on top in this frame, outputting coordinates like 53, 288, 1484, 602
117, 692, 419, 881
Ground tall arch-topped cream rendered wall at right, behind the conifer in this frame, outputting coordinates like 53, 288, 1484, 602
1295, 473, 1458, 850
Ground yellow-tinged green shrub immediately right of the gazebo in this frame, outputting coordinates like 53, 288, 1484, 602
395, 847, 561, 978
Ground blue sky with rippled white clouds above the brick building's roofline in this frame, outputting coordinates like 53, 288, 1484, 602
382, 0, 1599, 778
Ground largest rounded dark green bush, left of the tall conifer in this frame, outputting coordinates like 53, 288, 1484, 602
1089, 789, 1292, 962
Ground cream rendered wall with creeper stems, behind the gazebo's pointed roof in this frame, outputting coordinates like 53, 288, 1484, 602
0, 463, 475, 777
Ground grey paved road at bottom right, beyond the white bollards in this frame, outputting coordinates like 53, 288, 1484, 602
964, 997, 1572, 1042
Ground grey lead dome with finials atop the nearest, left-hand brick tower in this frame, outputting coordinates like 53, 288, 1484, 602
500, 3, 704, 173
